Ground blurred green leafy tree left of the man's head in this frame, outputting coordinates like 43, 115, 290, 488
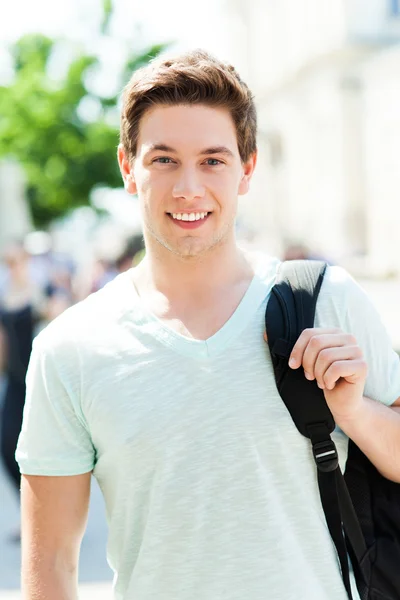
0, 27, 165, 227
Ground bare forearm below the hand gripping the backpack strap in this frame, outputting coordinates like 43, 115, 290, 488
337, 398, 400, 483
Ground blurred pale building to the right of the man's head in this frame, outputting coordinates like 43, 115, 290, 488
226, 0, 400, 276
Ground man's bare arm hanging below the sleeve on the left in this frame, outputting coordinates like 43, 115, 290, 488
21, 472, 91, 600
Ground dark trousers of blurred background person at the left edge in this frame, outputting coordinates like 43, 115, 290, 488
0, 378, 26, 494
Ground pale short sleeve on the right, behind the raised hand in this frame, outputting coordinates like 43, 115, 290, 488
316, 267, 400, 406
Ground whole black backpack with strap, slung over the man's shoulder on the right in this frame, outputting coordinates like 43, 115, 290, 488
265, 261, 400, 600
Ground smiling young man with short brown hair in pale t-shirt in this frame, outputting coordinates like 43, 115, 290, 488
17, 52, 400, 600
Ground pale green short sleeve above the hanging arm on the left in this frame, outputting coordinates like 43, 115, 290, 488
16, 332, 95, 476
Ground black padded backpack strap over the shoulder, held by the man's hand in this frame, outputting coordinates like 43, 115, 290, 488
265, 261, 367, 600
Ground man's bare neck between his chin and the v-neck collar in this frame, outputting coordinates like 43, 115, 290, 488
137, 240, 253, 300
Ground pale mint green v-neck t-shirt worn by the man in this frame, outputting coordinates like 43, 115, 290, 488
17, 256, 400, 600
